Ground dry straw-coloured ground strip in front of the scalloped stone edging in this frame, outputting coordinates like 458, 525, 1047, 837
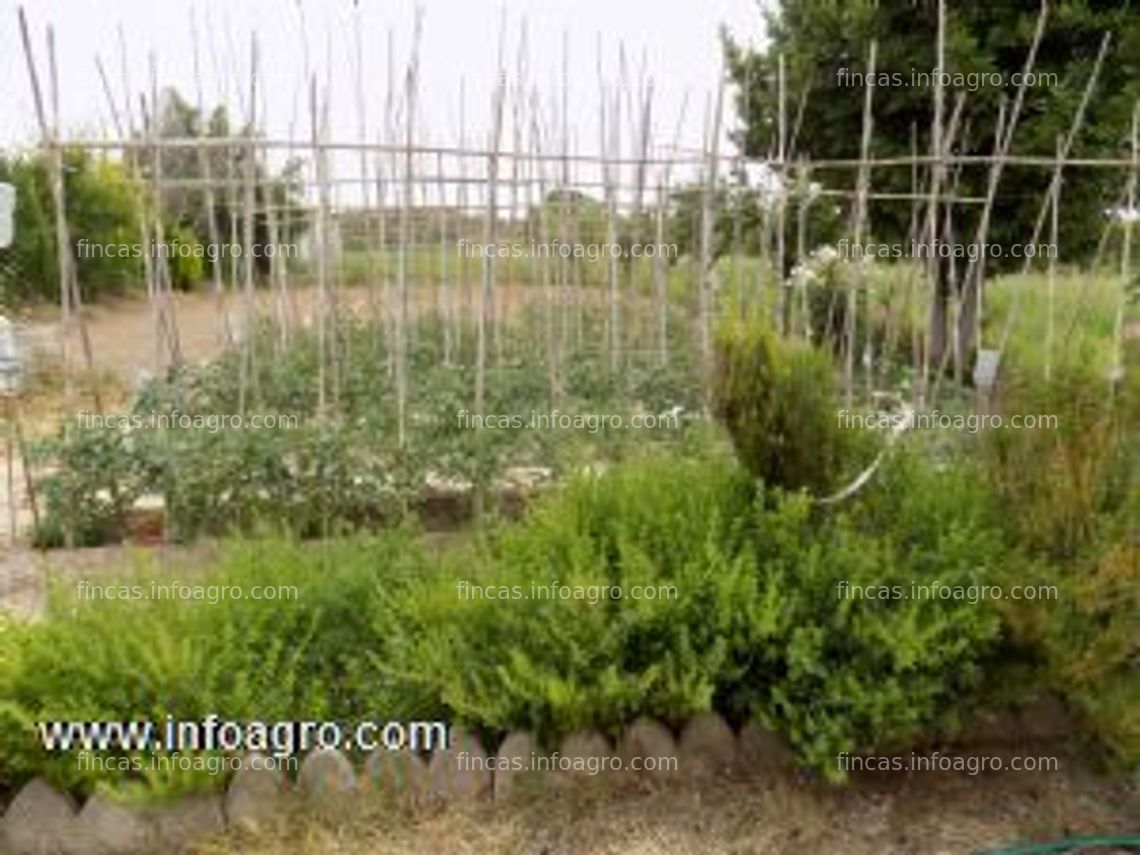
207, 748, 1140, 855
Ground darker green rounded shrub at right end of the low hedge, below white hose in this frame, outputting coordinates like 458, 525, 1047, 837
726, 455, 1011, 780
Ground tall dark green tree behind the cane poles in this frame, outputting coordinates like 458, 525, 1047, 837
725, 0, 1140, 365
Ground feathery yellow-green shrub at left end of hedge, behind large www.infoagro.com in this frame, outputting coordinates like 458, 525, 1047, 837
0, 535, 440, 798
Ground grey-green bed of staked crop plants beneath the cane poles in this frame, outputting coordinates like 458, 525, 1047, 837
31, 317, 700, 545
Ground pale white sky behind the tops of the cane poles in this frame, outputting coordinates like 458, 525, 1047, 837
0, 0, 763, 206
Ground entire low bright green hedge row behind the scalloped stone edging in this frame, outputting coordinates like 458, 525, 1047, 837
0, 438, 1030, 795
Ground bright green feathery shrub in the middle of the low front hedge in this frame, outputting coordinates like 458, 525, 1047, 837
378, 454, 755, 741
